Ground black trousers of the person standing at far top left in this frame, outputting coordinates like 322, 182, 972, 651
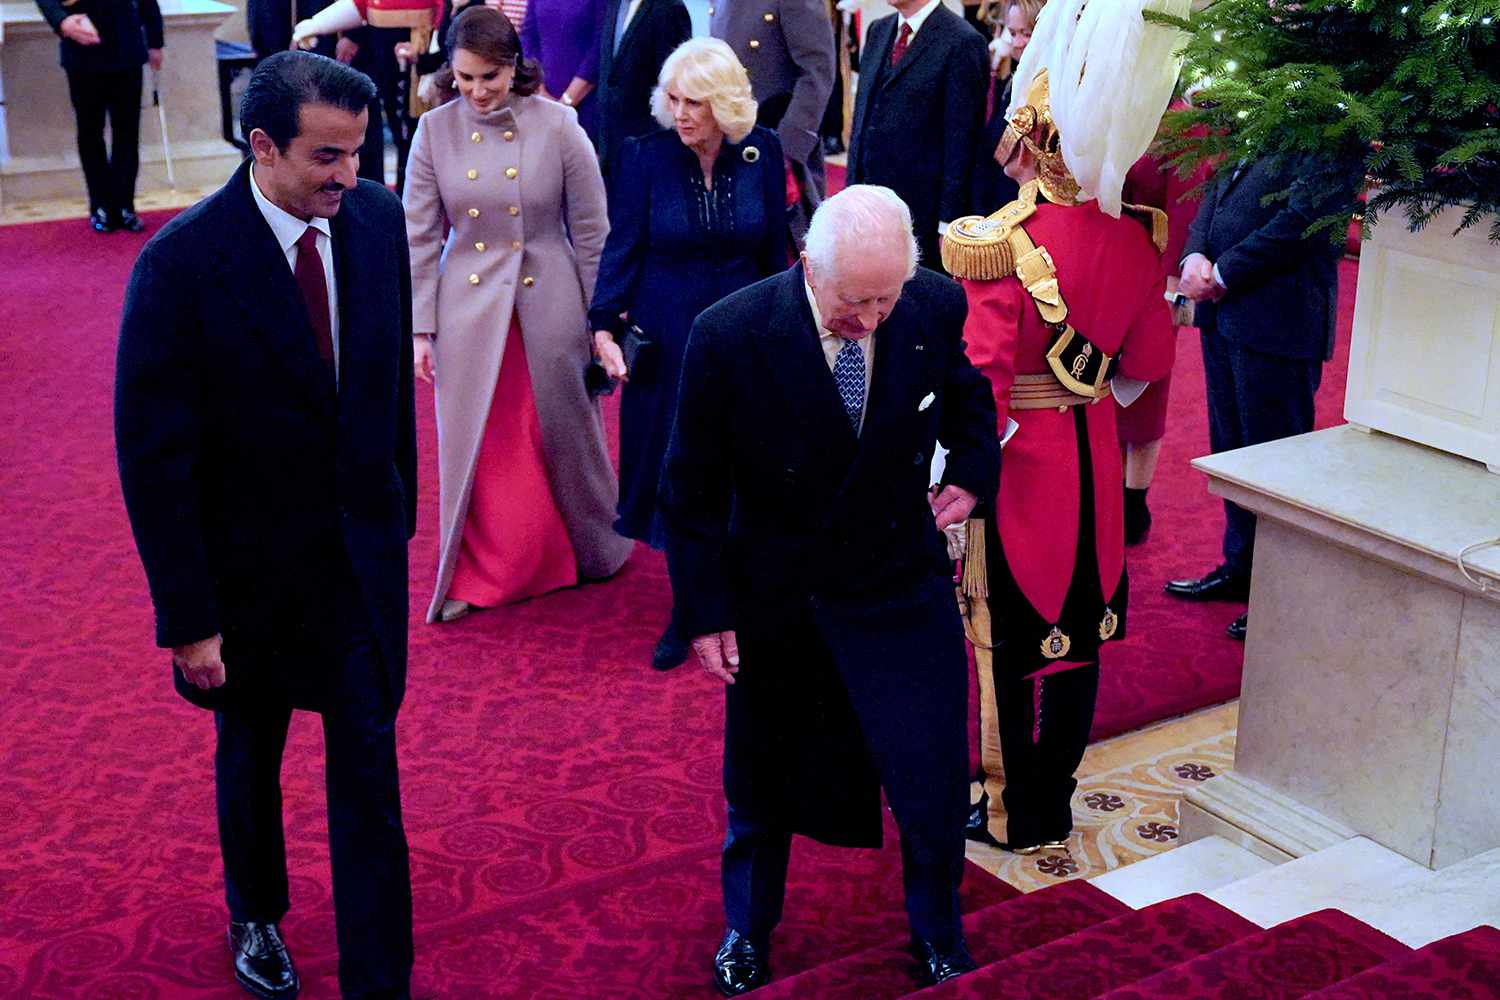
68, 66, 141, 214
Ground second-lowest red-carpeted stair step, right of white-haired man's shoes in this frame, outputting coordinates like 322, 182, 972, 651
912, 894, 1262, 1000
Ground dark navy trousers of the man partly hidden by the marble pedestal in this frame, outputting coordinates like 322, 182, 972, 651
1202, 328, 1323, 577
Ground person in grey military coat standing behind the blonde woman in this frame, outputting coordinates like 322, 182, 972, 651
708, 0, 834, 241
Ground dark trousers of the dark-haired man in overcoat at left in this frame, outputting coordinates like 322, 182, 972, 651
215, 582, 413, 997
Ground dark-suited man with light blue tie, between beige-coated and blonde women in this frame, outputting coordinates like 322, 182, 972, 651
594, 0, 693, 178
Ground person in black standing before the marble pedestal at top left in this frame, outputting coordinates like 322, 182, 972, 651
36, 0, 165, 232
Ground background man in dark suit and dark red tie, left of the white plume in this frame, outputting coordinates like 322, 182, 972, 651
849, 0, 998, 268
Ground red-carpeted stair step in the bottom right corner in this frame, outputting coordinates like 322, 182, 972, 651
1307, 925, 1500, 1000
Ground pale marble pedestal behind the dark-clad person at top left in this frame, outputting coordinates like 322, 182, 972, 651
0, 0, 240, 205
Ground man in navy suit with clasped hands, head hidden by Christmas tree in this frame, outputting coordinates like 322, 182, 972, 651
1167, 159, 1358, 639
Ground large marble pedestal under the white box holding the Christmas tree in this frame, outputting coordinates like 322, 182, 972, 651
1182, 426, 1500, 868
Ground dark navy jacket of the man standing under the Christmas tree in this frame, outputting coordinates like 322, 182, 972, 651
1182, 159, 1359, 361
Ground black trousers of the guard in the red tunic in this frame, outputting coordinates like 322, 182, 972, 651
995, 663, 1100, 847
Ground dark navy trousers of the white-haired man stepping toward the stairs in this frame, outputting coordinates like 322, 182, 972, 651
722, 622, 968, 948
